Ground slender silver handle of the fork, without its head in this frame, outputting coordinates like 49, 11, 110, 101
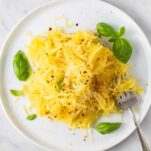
130, 108, 151, 151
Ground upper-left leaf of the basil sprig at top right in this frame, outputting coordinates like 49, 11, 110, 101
96, 22, 117, 37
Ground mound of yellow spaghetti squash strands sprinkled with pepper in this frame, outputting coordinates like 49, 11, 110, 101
23, 28, 142, 128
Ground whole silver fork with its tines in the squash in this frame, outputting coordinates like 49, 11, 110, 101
117, 91, 151, 151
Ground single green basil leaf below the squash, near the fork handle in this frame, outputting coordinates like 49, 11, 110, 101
95, 122, 121, 134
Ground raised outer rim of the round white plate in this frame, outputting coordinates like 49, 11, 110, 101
0, 0, 151, 151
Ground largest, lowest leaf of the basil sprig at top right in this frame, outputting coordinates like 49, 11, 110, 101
113, 38, 132, 63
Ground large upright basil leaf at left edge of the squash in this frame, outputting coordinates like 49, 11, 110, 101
13, 50, 31, 81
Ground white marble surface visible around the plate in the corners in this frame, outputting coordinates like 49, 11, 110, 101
0, 0, 151, 151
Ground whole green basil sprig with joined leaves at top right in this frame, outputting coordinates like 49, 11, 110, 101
96, 22, 132, 63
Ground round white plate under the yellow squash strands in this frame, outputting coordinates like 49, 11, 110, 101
0, 0, 151, 151
